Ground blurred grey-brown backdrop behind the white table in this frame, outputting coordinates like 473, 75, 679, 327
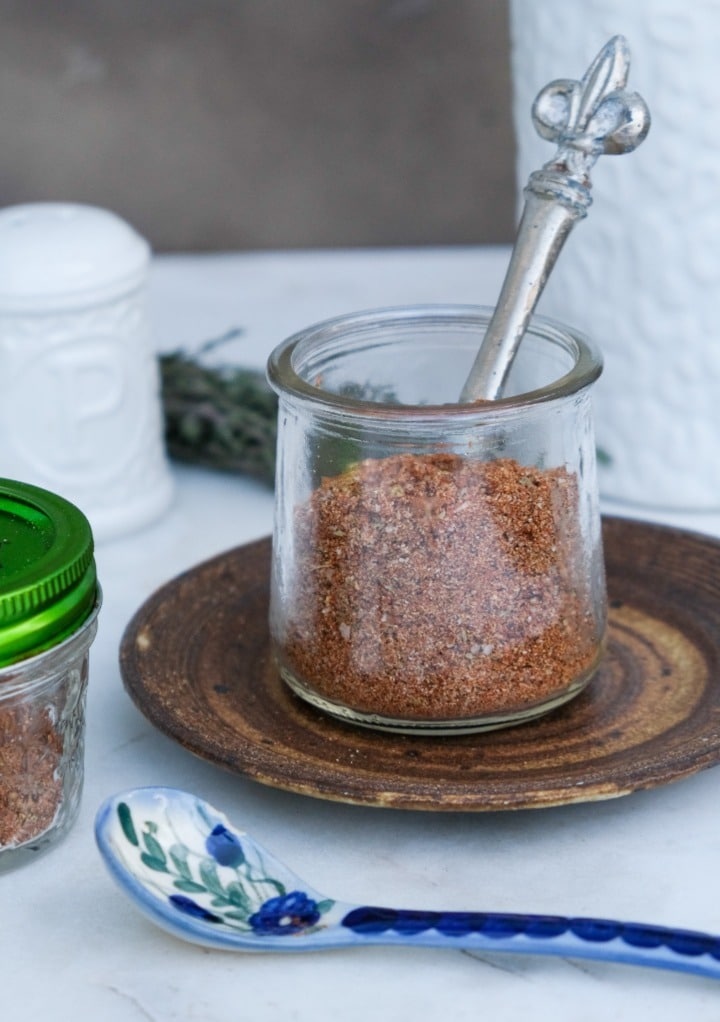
0, 0, 515, 251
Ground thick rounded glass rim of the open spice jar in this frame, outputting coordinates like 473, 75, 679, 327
267, 304, 603, 420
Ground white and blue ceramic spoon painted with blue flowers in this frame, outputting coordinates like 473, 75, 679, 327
95, 788, 720, 978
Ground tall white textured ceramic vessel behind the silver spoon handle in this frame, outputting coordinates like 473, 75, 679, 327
511, 0, 720, 511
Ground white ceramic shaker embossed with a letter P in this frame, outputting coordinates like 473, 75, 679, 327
0, 202, 173, 541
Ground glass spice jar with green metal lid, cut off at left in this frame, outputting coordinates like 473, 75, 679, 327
0, 479, 100, 871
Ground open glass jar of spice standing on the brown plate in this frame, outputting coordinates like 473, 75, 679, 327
268, 306, 607, 735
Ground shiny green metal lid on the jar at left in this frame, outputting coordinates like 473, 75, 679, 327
0, 479, 97, 667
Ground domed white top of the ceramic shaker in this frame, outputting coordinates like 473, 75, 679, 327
0, 202, 150, 312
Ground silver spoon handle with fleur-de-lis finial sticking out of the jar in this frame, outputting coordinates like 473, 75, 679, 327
461, 36, 651, 402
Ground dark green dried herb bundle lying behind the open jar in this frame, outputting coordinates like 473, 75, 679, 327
159, 331, 278, 485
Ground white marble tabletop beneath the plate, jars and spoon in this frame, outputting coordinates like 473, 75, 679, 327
8, 249, 720, 1022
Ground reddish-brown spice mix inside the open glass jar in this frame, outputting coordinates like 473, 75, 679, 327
280, 453, 603, 726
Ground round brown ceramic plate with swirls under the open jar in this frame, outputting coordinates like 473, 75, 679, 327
121, 519, 720, 811
